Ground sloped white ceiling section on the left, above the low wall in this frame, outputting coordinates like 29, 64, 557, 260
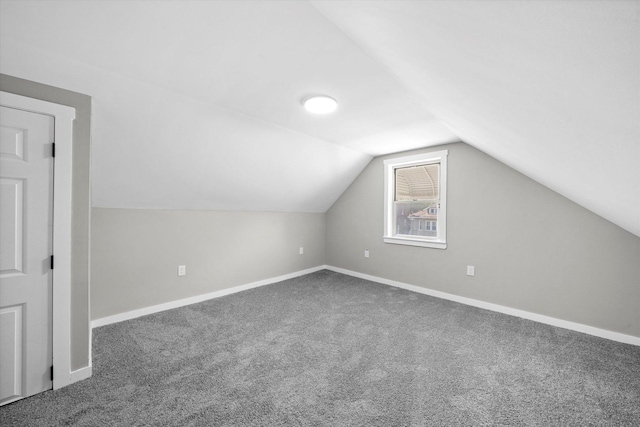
0, 38, 372, 213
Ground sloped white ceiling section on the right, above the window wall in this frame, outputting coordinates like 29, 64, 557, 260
313, 1, 640, 235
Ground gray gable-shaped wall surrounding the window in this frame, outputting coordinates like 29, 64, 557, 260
326, 143, 640, 336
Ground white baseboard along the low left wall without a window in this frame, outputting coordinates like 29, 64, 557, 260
91, 265, 327, 329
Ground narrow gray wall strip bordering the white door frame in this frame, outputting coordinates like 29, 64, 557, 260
0, 74, 91, 370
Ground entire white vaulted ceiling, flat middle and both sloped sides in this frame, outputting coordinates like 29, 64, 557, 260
0, 0, 640, 235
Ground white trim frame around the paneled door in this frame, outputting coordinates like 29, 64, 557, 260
0, 92, 77, 389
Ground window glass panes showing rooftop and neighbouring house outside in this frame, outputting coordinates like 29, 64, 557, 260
394, 163, 440, 237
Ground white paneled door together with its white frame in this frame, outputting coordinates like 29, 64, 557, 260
0, 92, 75, 405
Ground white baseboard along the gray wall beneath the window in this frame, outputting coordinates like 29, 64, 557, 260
324, 265, 640, 346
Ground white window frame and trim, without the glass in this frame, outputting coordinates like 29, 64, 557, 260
383, 150, 449, 249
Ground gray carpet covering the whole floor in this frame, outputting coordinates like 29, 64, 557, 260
0, 271, 640, 426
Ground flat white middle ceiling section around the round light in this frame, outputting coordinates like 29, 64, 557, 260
1, 1, 458, 154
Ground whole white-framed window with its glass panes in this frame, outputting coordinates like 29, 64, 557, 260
384, 150, 448, 249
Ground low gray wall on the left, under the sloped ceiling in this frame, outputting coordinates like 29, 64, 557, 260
91, 208, 325, 319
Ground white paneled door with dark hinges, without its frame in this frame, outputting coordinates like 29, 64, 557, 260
0, 107, 54, 405
